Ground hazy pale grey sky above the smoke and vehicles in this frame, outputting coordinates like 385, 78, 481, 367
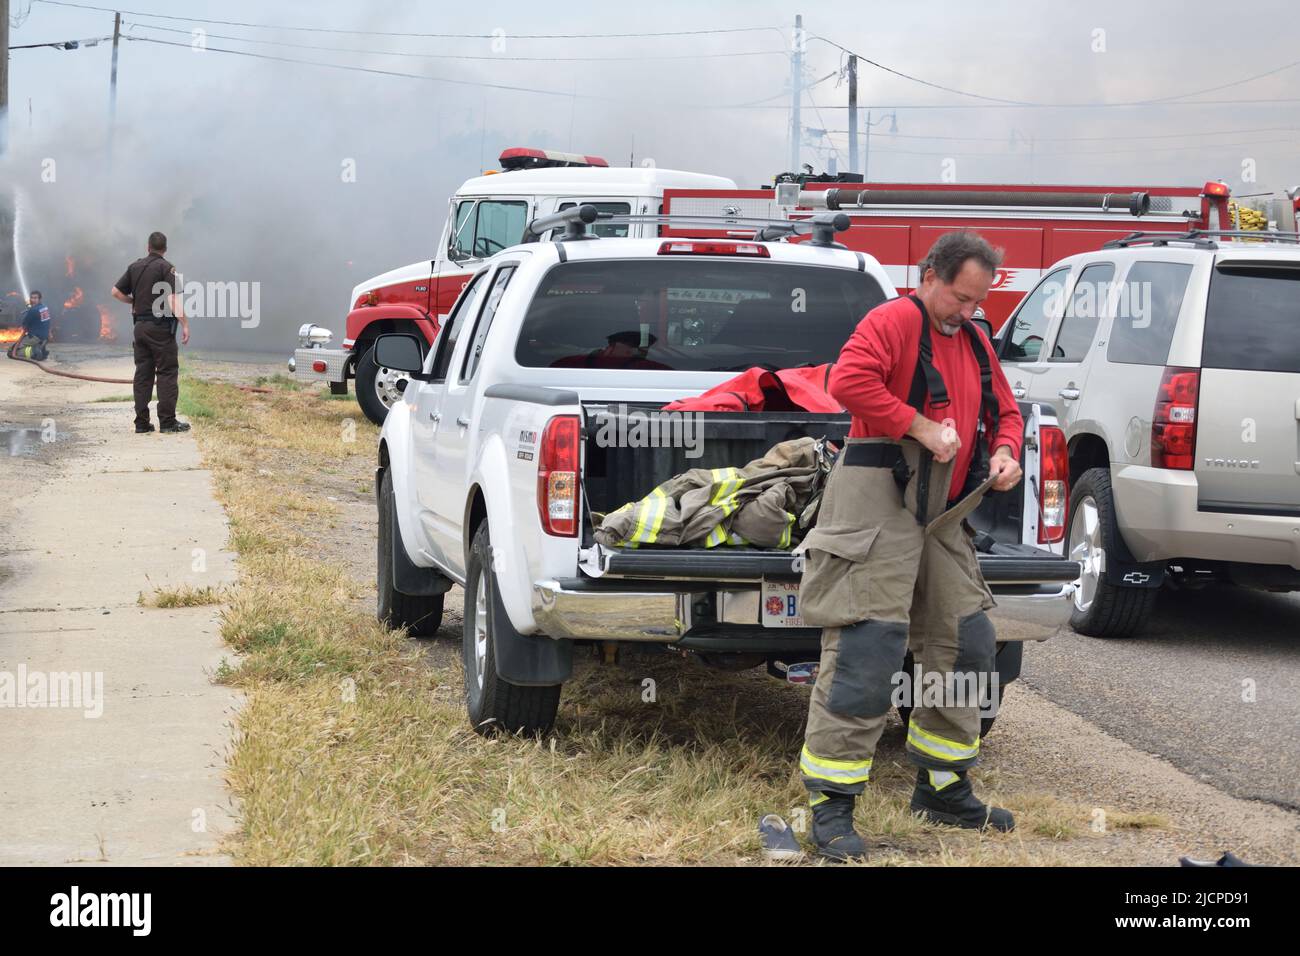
7, 0, 1300, 348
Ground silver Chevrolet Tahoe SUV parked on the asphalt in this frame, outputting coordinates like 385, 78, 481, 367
997, 232, 1300, 637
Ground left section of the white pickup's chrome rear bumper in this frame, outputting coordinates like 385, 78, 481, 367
533, 580, 690, 644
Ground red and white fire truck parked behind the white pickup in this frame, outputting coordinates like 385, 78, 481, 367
289, 147, 1279, 423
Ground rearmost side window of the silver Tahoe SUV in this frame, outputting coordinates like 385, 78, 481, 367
1106, 263, 1192, 365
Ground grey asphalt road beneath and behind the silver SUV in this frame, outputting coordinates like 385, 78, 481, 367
993, 588, 1300, 809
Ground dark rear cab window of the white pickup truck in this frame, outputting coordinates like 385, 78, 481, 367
515, 256, 885, 372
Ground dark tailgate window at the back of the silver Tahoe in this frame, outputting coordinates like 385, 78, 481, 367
1201, 263, 1300, 372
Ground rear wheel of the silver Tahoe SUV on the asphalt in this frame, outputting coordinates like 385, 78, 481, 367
1066, 468, 1158, 637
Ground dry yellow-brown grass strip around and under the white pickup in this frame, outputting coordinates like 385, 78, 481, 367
186, 381, 1161, 865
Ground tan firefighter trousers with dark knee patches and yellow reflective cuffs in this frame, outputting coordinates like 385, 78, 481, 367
800, 438, 997, 805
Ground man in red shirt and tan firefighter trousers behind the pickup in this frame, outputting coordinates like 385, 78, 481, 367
800, 232, 1023, 860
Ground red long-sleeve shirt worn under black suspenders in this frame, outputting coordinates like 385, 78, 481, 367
829, 297, 1024, 498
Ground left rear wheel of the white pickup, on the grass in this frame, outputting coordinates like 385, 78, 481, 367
462, 522, 562, 736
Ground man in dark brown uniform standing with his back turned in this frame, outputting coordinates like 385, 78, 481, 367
113, 233, 190, 433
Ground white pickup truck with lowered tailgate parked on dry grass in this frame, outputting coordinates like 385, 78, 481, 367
376, 207, 1079, 732
